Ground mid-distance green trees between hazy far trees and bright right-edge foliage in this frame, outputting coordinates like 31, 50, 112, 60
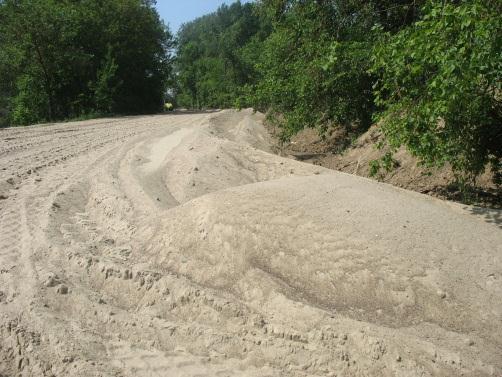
248, 0, 420, 138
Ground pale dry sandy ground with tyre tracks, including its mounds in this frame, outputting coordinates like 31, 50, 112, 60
0, 110, 502, 377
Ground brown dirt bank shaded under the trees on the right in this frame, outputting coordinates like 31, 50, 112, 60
268, 124, 502, 209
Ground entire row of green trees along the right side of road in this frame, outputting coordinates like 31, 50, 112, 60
175, 0, 502, 183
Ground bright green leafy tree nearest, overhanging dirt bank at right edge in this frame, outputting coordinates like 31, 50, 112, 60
372, 0, 502, 180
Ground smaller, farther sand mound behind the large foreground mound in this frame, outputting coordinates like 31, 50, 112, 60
162, 111, 333, 203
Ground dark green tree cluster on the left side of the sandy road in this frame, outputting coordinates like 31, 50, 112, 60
0, 0, 173, 126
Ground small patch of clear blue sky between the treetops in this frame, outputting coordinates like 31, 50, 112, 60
157, 0, 251, 33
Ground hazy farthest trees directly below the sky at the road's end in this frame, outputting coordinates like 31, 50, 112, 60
176, 2, 267, 108
